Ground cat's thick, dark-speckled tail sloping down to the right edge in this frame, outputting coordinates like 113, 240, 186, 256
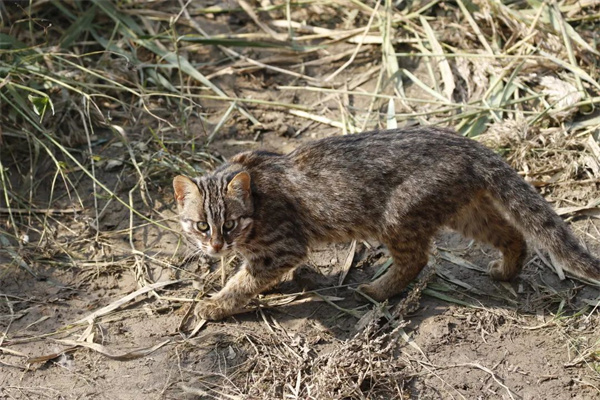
488, 166, 600, 285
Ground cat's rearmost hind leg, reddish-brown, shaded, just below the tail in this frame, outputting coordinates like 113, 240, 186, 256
447, 192, 527, 281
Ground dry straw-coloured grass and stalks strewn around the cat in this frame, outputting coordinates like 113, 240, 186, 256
0, 0, 600, 399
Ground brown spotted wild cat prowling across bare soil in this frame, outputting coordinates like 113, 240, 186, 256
173, 127, 600, 320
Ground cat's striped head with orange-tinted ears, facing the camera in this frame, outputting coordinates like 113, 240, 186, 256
173, 171, 253, 257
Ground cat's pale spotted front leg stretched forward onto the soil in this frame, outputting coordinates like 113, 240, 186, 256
195, 263, 290, 320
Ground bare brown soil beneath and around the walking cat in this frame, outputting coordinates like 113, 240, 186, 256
0, 3, 600, 400
